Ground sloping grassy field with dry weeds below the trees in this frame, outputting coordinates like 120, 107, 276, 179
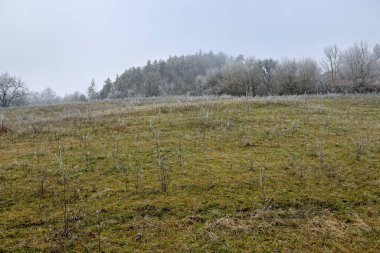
0, 95, 380, 252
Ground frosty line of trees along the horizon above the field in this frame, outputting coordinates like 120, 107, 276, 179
0, 41, 380, 107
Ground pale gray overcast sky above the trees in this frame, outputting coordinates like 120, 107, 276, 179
0, 0, 380, 95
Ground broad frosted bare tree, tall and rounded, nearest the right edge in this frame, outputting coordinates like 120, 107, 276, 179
344, 41, 375, 89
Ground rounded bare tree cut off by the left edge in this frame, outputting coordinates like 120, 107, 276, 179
0, 73, 27, 107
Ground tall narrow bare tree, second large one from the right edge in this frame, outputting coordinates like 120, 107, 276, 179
321, 44, 342, 90
